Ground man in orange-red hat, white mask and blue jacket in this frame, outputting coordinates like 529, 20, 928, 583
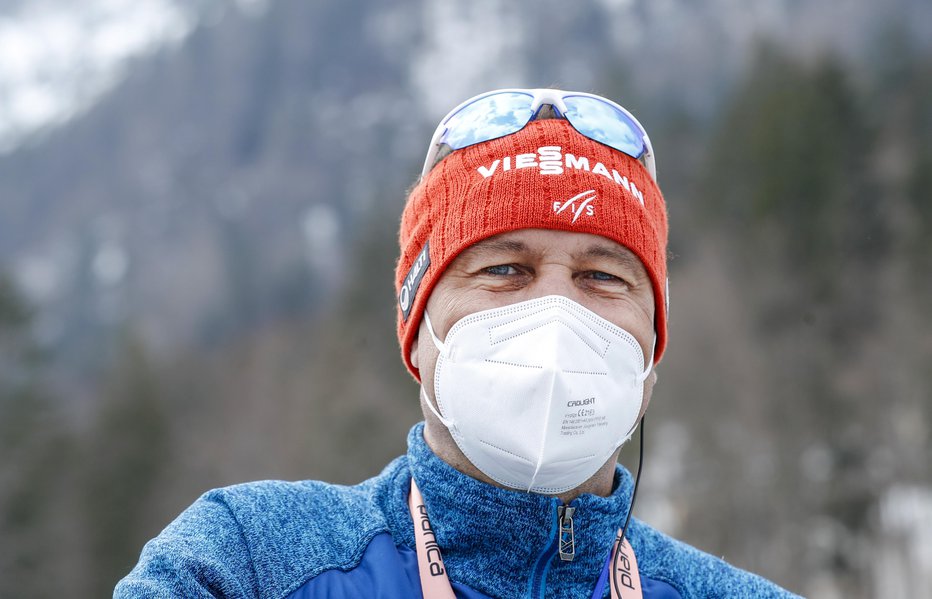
115, 90, 791, 598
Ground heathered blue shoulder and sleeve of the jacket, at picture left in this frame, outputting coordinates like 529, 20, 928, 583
114, 458, 404, 599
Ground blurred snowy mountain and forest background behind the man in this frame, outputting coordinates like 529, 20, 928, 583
0, 0, 932, 598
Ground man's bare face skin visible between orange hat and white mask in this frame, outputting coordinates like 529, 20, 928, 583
411, 229, 655, 424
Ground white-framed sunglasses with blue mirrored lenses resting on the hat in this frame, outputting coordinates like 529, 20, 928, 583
421, 89, 657, 181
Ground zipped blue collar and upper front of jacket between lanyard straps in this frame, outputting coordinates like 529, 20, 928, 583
391, 423, 633, 597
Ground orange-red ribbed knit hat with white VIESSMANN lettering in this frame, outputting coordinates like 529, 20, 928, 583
395, 119, 667, 380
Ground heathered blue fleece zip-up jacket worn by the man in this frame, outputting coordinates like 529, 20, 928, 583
114, 424, 794, 599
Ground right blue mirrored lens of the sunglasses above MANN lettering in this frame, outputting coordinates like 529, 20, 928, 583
563, 96, 647, 158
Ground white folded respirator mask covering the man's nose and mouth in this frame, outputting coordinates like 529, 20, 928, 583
422, 295, 652, 494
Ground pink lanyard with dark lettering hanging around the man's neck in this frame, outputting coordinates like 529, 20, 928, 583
408, 477, 643, 599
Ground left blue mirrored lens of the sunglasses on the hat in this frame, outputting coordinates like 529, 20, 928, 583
440, 92, 534, 150
